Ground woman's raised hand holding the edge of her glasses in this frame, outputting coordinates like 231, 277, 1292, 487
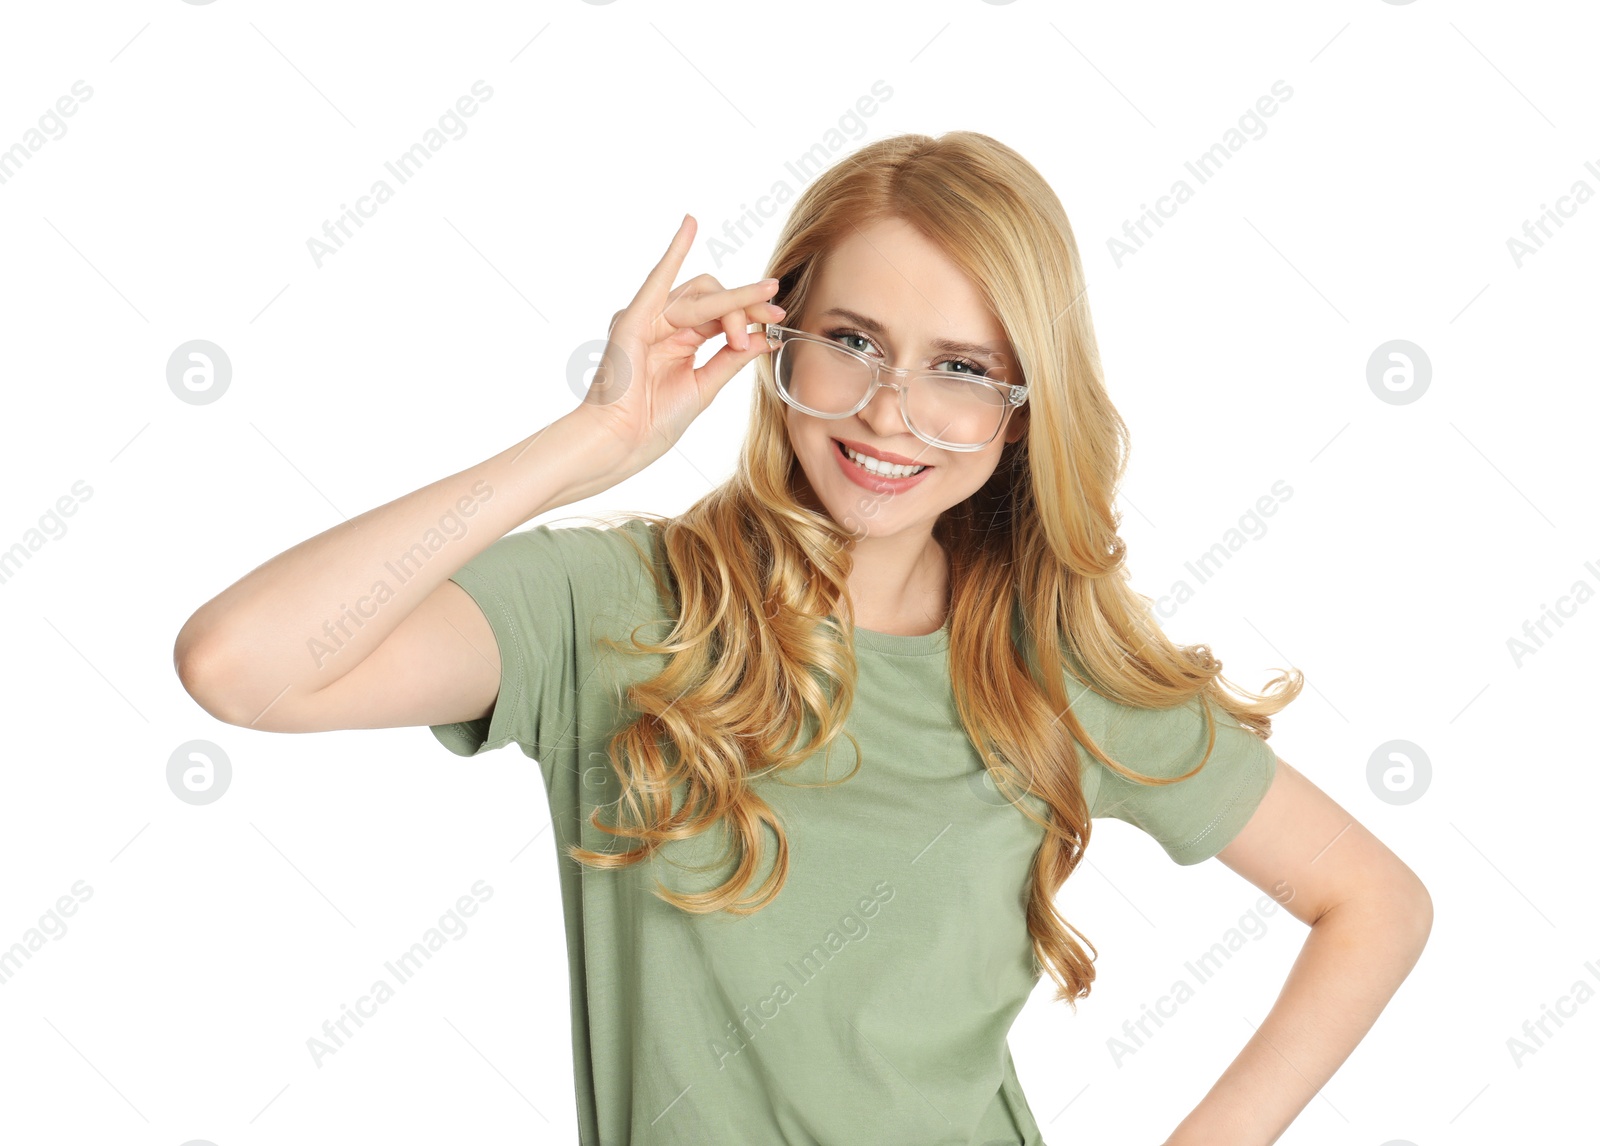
571, 214, 784, 482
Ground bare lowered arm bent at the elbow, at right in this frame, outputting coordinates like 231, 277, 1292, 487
1166, 757, 1434, 1146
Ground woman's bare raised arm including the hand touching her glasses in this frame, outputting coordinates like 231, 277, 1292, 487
173, 216, 782, 731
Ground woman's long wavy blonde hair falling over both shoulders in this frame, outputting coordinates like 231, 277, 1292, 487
568, 131, 1304, 1010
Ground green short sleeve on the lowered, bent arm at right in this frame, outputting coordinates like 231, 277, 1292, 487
1080, 696, 1278, 864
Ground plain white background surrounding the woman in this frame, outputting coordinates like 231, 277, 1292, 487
0, 0, 1600, 1146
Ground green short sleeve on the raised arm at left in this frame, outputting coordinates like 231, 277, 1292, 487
429, 525, 584, 759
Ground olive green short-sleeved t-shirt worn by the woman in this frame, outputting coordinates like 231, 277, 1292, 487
432, 519, 1277, 1146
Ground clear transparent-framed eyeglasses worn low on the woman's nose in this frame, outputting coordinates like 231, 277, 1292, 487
765, 322, 1027, 451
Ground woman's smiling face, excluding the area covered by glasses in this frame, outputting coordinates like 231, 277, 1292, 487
784, 219, 1027, 538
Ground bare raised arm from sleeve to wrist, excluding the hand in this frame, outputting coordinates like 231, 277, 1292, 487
173, 415, 611, 731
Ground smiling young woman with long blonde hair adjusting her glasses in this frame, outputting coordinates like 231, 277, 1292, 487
176, 131, 1432, 1146
